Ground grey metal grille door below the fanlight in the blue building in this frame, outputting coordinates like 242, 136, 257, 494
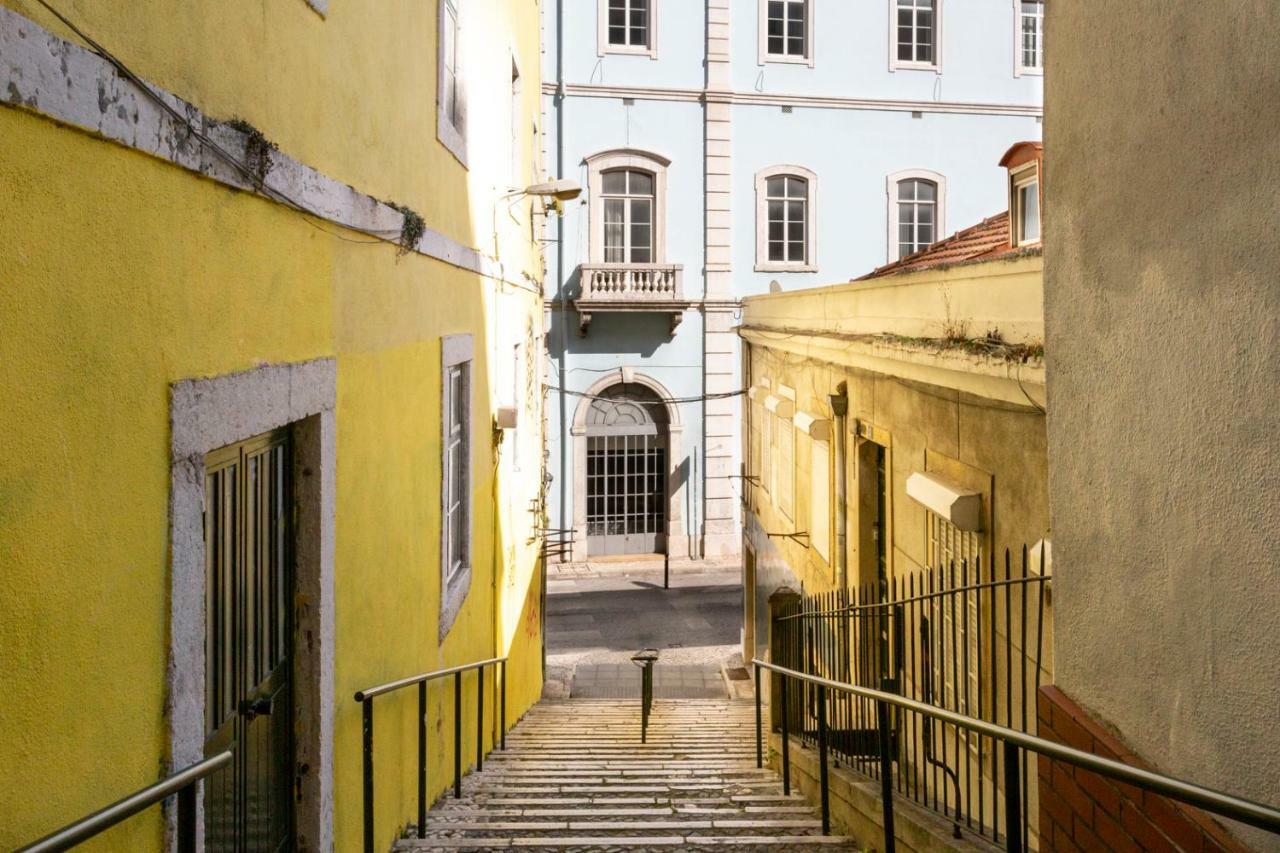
586, 434, 667, 556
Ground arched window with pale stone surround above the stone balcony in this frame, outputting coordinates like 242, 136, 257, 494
586, 150, 671, 264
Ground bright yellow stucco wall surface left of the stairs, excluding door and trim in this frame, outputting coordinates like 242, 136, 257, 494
0, 0, 541, 850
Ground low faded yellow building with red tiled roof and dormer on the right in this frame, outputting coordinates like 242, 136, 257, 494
739, 142, 1052, 831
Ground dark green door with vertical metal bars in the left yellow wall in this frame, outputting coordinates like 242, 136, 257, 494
205, 430, 294, 853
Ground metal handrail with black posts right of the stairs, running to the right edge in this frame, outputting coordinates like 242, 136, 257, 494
751, 660, 1280, 853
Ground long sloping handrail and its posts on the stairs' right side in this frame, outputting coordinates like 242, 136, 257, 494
751, 658, 1280, 853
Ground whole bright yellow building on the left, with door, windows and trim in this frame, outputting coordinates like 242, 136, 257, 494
0, 0, 544, 850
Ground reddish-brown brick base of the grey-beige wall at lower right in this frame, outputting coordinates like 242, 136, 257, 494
1037, 685, 1248, 853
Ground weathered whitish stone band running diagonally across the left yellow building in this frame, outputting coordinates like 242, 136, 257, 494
0, 5, 540, 288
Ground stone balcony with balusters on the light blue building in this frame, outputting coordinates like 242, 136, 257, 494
573, 264, 689, 334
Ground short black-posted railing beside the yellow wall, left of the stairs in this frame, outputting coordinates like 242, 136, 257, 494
356, 657, 507, 853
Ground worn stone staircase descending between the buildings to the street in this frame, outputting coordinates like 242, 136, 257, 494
396, 699, 859, 852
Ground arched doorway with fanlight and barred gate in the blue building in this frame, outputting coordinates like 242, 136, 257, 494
585, 383, 669, 557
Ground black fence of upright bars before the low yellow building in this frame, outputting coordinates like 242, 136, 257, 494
771, 548, 1052, 841
